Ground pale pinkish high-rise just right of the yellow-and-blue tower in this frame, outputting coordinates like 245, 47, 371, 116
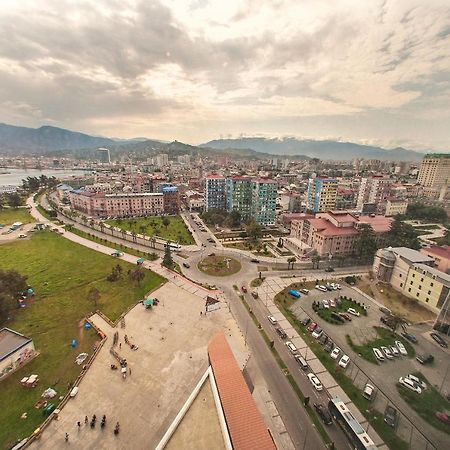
356, 175, 392, 214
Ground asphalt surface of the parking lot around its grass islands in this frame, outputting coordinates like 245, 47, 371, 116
291, 285, 450, 449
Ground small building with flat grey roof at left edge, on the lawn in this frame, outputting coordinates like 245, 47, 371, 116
0, 327, 36, 379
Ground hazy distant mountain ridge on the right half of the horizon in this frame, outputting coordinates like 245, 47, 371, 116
201, 137, 423, 161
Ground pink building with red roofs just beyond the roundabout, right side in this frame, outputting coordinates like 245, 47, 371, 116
286, 211, 393, 257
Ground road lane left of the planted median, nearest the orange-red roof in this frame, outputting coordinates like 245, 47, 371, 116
222, 286, 326, 450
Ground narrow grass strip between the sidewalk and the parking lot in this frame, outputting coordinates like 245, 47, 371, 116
275, 296, 409, 450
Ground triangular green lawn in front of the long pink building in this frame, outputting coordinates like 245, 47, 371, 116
105, 216, 195, 245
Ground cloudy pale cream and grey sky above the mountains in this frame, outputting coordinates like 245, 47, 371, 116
0, 0, 450, 150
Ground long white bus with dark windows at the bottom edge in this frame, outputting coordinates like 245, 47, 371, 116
328, 397, 377, 450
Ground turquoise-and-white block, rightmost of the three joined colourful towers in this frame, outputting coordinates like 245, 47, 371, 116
251, 178, 278, 226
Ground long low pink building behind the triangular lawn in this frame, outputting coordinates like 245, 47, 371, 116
69, 190, 165, 217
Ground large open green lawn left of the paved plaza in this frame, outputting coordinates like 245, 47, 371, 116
0, 231, 164, 448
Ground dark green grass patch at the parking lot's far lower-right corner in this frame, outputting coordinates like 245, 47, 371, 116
397, 372, 450, 434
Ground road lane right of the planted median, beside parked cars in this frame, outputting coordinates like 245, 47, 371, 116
246, 295, 351, 449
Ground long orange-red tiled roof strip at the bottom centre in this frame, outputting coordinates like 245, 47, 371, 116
208, 333, 276, 450
